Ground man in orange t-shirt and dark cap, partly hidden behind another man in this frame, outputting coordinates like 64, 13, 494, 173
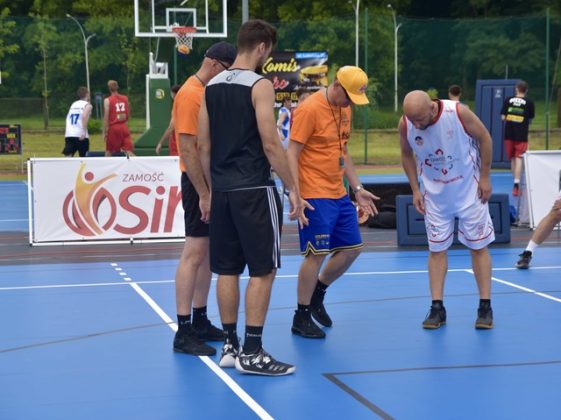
168, 42, 236, 356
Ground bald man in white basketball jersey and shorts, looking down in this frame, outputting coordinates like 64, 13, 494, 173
399, 90, 495, 329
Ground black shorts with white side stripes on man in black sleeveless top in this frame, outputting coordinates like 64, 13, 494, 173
210, 187, 282, 277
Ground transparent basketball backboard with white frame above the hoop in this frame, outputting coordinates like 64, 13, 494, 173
134, 0, 228, 38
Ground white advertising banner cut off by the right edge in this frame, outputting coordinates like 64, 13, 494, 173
524, 150, 561, 229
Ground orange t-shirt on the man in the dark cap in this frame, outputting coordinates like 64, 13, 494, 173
172, 76, 205, 172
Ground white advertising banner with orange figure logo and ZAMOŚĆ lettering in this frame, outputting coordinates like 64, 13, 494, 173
29, 156, 185, 243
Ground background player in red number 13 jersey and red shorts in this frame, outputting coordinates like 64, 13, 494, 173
103, 80, 134, 156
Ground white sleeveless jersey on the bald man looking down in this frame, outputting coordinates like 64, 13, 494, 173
405, 100, 481, 214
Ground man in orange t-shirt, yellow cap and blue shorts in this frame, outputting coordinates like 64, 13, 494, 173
287, 66, 378, 338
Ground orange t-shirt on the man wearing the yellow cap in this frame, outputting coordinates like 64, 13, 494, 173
290, 89, 351, 198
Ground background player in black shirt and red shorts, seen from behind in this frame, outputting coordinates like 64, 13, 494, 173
501, 80, 535, 197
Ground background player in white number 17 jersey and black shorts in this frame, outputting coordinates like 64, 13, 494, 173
62, 86, 92, 157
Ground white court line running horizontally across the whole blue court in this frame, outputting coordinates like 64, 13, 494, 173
0, 264, 561, 293
